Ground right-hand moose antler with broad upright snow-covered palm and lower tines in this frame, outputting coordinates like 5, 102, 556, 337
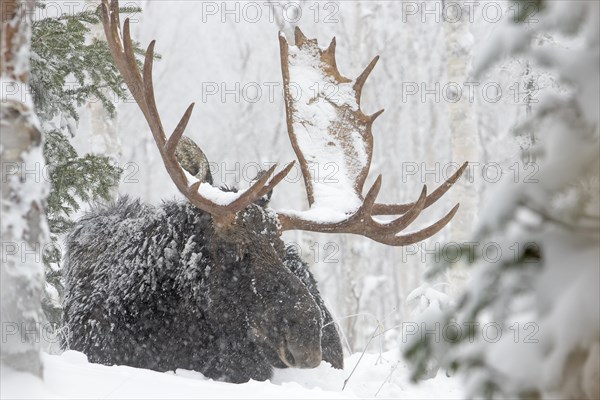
278, 28, 467, 246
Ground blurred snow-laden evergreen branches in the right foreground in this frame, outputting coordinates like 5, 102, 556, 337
403, 1, 600, 398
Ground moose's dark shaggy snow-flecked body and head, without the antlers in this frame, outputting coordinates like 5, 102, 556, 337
64, 198, 343, 382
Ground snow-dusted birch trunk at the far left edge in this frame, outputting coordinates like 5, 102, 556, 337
0, 0, 48, 377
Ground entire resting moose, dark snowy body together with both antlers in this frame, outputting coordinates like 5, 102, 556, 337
65, 0, 466, 382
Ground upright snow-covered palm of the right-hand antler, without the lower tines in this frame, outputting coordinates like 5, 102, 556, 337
279, 28, 383, 212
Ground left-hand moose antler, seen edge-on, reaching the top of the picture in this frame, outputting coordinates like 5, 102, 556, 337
102, 0, 294, 222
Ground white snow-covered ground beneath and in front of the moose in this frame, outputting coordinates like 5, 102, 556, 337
0, 351, 463, 399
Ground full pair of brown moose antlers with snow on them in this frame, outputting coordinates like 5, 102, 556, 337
102, 0, 467, 246
